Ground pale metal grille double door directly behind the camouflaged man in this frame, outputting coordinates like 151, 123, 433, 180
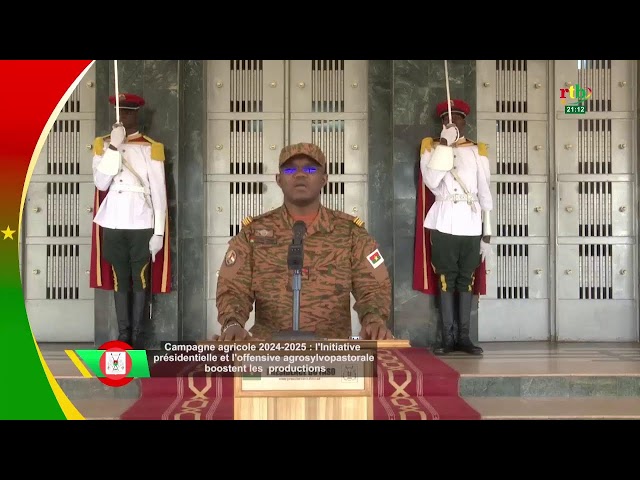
207, 60, 367, 336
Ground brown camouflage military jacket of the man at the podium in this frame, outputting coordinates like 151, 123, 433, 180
216, 206, 391, 339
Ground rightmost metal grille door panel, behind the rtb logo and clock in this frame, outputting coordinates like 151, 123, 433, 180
554, 60, 638, 341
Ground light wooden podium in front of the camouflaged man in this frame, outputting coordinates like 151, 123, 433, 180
234, 340, 411, 420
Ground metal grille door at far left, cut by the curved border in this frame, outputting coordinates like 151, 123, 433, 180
21, 67, 95, 342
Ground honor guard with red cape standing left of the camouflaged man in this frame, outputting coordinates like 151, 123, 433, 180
91, 93, 170, 348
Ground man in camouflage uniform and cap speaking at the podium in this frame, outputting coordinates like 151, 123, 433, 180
216, 143, 393, 341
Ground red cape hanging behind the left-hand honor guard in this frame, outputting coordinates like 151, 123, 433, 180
89, 188, 171, 293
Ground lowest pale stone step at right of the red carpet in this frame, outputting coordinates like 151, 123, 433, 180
465, 397, 640, 420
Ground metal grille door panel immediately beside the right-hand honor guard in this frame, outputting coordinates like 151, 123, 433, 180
477, 60, 551, 341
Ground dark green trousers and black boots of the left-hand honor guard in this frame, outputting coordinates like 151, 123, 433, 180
102, 228, 153, 349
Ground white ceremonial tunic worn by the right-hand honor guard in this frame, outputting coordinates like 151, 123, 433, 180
420, 137, 493, 236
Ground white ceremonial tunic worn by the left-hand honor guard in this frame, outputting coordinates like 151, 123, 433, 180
93, 132, 167, 235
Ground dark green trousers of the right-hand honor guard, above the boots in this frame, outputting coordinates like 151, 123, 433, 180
431, 230, 481, 292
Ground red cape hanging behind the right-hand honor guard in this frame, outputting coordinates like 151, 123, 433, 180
413, 144, 487, 295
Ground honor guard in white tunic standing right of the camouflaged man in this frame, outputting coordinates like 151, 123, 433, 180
420, 100, 493, 355
